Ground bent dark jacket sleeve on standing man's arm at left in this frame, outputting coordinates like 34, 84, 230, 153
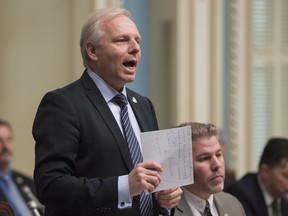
33, 89, 117, 213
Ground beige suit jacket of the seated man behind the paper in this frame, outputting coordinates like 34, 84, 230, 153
175, 192, 245, 216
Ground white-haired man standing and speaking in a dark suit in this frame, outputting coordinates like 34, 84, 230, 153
33, 8, 182, 216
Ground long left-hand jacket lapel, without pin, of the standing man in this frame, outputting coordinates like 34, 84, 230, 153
81, 71, 133, 170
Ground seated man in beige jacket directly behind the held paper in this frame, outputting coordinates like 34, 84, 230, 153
175, 122, 245, 216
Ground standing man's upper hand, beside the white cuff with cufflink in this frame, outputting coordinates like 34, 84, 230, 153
128, 161, 163, 196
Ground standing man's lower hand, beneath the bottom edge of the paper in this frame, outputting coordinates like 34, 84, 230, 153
155, 188, 183, 208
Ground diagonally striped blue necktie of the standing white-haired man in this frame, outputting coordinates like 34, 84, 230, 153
113, 94, 153, 216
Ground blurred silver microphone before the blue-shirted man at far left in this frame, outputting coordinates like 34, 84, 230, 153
22, 185, 44, 216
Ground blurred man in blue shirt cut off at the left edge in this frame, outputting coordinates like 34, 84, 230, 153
0, 119, 41, 216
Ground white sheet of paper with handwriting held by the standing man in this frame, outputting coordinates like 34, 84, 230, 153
140, 126, 194, 192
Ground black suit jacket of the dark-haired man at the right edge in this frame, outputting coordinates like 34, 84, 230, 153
224, 173, 288, 216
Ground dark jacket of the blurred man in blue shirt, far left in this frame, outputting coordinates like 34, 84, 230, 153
0, 170, 36, 208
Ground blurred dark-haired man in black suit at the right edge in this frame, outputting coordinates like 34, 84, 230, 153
225, 138, 288, 216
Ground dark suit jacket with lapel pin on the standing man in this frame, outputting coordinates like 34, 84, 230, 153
33, 71, 163, 216
